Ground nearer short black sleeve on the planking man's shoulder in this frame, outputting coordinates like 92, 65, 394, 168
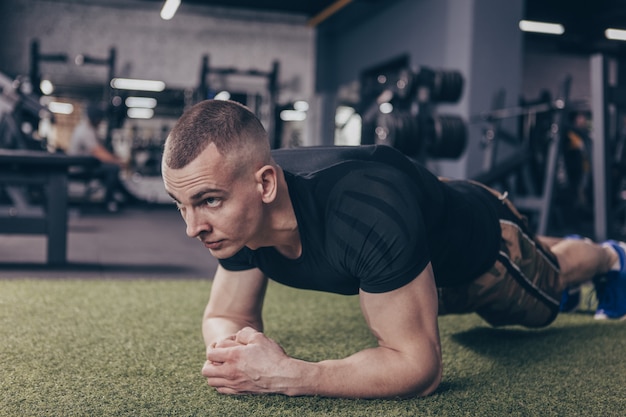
326, 164, 430, 293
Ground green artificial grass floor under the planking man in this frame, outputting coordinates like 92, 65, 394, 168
0, 279, 626, 417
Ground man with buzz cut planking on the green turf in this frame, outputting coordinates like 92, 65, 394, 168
162, 101, 626, 398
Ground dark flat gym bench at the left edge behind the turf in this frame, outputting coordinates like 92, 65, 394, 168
0, 149, 99, 265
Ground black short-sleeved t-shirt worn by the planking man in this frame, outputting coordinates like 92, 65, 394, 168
219, 146, 500, 294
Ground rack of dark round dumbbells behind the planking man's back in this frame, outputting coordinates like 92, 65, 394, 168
358, 56, 467, 159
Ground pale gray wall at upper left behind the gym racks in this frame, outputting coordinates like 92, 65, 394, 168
0, 0, 315, 143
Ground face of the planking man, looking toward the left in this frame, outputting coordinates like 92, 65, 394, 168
163, 144, 263, 258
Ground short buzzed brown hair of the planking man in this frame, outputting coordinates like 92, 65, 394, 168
163, 100, 270, 169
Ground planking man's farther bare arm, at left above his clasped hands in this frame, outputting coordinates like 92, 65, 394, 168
202, 266, 267, 349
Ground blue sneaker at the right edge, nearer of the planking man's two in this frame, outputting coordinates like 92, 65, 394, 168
594, 240, 626, 320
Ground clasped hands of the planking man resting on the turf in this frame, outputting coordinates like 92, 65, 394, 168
202, 327, 290, 394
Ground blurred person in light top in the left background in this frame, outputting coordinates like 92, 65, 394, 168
67, 103, 128, 212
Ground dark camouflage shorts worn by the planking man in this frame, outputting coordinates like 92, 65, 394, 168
438, 184, 561, 327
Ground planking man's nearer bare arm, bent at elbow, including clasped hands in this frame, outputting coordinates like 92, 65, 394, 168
203, 265, 442, 398
